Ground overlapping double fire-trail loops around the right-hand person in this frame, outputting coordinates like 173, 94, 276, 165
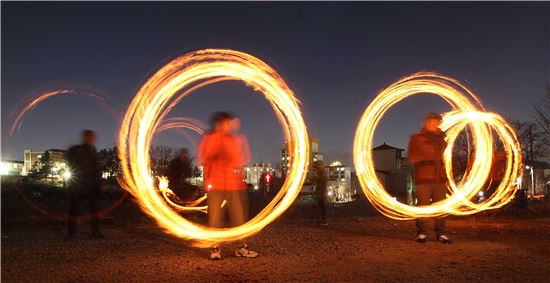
353, 73, 521, 220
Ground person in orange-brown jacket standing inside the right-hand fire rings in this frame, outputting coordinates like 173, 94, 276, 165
408, 113, 451, 243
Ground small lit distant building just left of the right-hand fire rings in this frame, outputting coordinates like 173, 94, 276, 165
326, 161, 356, 202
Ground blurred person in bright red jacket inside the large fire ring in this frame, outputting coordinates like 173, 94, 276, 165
198, 112, 258, 260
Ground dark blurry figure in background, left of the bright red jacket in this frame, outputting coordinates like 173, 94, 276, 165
167, 148, 196, 201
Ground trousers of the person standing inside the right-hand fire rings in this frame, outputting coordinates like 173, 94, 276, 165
416, 184, 447, 237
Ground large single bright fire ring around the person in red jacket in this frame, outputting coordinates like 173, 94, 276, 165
118, 49, 309, 247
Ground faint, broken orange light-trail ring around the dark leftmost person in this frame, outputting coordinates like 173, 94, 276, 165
6, 83, 128, 221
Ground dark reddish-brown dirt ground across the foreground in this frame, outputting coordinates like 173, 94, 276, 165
1, 206, 550, 282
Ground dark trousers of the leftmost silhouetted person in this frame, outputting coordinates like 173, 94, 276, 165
67, 192, 99, 236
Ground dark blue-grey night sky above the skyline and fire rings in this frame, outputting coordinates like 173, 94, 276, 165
1, 2, 550, 165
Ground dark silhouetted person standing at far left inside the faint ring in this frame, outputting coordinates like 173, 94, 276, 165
66, 130, 103, 240
